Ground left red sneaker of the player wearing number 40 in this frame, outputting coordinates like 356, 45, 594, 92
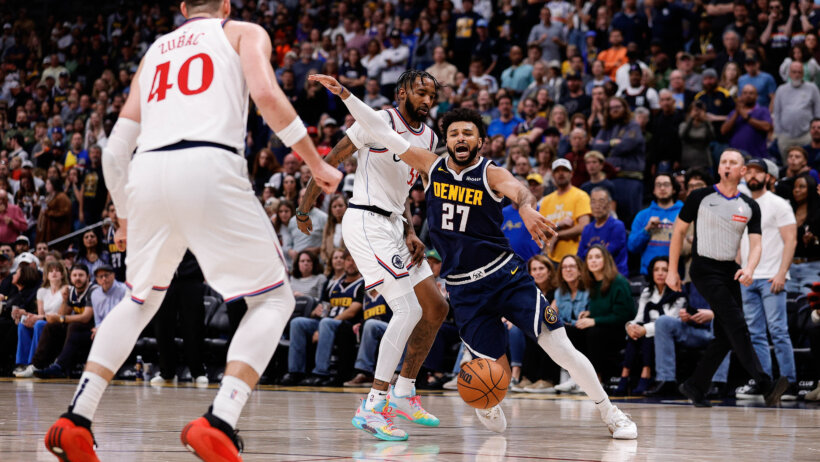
45, 412, 100, 462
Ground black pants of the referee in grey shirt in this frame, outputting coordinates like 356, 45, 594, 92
688, 257, 772, 393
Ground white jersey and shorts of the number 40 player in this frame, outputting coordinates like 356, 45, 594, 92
126, 18, 289, 303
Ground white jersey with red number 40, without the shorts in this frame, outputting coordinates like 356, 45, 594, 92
137, 18, 248, 152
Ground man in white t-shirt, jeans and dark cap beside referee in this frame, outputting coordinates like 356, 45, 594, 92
736, 159, 797, 400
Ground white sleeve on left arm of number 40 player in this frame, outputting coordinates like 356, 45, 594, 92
102, 117, 140, 219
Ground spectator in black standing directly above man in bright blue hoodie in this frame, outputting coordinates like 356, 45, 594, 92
647, 90, 684, 173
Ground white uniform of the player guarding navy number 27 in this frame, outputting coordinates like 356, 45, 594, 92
342, 108, 438, 301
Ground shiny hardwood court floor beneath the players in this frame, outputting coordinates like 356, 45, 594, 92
0, 380, 820, 462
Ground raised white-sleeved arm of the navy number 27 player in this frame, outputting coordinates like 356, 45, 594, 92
308, 74, 438, 172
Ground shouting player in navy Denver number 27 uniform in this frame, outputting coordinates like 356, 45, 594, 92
310, 75, 638, 439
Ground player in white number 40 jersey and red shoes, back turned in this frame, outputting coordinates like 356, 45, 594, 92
45, 0, 341, 462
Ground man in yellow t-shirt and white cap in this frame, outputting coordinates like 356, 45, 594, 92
538, 159, 592, 262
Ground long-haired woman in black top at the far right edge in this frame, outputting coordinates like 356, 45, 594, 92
786, 173, 820, 294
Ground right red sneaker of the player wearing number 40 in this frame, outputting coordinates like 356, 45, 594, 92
179, 410, 244, 462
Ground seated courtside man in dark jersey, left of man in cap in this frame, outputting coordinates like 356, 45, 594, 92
32, 265, 94, 379
